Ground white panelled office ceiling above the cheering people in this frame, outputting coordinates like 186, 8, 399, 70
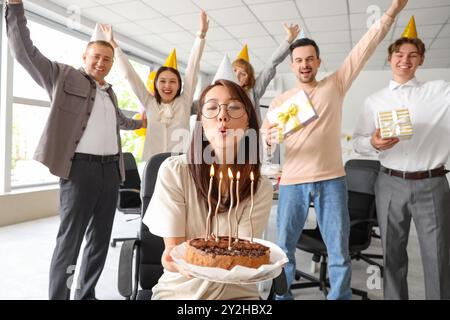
38, 0, 450, 74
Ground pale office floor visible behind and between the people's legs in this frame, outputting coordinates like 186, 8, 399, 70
0, 207, 425, 300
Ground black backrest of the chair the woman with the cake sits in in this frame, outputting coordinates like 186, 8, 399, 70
139, 152, 176, 290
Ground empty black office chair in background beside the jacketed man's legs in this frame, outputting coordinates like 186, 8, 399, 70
111, 152, 141, 247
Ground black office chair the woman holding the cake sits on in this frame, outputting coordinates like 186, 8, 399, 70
118, 153, 287, 300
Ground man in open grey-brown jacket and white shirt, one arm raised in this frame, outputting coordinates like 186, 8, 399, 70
5, 0, 147, 299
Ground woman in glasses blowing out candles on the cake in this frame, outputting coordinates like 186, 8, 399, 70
143, 80, 272, 300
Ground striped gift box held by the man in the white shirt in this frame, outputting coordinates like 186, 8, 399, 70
378, 109, 413, 139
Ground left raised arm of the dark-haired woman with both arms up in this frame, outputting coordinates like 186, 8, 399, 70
99, 24, 154, 108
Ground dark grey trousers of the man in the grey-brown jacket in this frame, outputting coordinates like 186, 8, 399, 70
49, 160, 120, 300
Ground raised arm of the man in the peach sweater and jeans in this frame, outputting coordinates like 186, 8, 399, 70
335, 0, 408, 93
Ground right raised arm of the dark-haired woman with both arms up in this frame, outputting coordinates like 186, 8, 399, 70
178, 11, 209, 104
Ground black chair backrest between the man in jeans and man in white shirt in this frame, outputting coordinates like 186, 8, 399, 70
345, 159, 380, 252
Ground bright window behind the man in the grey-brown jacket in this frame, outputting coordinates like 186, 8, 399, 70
11, 20, 87, 188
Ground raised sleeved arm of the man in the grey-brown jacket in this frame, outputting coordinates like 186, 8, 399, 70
6, 0, 59, 95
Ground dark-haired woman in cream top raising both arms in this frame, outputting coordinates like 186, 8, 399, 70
101, 11, 209, 161
